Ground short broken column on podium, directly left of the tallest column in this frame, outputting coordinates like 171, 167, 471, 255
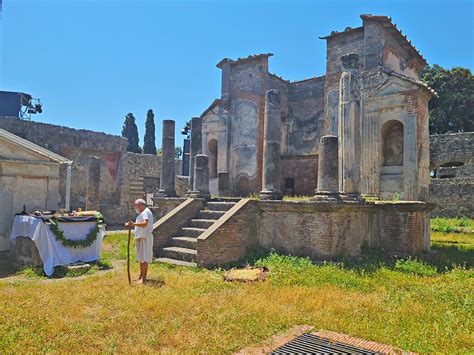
313, 136, 339, 200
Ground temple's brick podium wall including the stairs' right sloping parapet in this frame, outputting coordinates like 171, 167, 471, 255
194, 200, 431, 266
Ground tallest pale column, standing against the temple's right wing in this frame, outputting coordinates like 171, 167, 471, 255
338, 53, 362, 199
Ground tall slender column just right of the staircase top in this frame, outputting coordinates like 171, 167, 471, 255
260, 90, 283, 200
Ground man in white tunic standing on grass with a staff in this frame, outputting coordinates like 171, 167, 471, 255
125, 199, 153, 283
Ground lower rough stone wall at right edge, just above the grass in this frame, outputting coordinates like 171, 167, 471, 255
430, 178, 474, 218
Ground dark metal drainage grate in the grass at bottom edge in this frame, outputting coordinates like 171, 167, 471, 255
272, 334, 380, 354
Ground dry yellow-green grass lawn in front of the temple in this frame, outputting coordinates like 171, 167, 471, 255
0, 222, 474, 353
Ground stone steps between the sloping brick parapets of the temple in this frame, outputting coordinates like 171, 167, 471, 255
157, 200, 238, 267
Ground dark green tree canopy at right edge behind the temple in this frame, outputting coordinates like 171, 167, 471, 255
421, 64, 474, 134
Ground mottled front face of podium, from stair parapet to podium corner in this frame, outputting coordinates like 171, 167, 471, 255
258, 201, 374, 260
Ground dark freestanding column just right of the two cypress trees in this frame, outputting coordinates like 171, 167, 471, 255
158, 120, 176, 197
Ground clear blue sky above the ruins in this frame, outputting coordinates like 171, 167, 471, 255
0, 0, 474, 146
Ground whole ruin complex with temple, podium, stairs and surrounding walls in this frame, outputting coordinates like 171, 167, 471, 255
0, 15, 473, 266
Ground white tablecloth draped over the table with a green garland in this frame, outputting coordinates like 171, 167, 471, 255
10, 216, 105, 276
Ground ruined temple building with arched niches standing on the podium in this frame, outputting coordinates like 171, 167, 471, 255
200, 15, 433, 200
